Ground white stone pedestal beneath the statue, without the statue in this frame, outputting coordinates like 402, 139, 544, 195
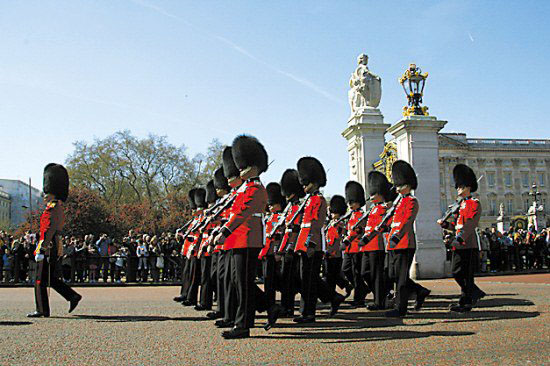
342, 107, 390, 191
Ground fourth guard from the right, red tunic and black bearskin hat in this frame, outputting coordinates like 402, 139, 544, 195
342, 181, 369, 307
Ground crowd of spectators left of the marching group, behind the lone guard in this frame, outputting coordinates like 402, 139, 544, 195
0, 230, 185, 284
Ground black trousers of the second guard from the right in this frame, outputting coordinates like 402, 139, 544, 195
388, 248, 424, 314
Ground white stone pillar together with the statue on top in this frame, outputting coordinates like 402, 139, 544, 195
342, 54, 390, 189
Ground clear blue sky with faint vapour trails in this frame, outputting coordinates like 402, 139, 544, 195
0, 0, 550, 194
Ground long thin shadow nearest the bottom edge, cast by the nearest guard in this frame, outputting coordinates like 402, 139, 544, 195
254, 330, 475, 343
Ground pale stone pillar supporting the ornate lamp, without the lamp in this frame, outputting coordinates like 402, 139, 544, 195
387, 116, 447, 279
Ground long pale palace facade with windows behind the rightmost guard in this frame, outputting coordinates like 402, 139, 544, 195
439, 133, 550, 228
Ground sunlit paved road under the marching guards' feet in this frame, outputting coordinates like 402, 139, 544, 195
0, 274, 550, 365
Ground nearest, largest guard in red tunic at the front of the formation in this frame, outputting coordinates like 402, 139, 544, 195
215, 135, 279, 339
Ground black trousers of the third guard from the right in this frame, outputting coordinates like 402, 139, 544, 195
361, 250, 386, 308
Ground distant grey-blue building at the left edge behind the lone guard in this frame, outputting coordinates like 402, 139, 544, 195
0, 179, 43, 228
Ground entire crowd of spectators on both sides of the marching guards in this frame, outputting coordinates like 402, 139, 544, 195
4, 224, 550, 284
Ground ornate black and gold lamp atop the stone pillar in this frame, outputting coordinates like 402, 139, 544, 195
399, 64, 428, 116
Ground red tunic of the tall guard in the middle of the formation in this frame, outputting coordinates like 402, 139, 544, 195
294, 193, 327, 252
